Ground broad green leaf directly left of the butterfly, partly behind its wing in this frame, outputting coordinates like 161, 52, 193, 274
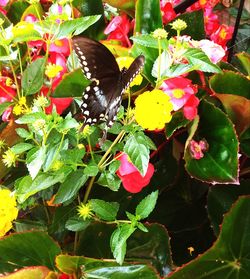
53, 69, 91, 98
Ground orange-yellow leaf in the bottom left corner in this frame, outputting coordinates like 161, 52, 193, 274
1, 266, 50, 279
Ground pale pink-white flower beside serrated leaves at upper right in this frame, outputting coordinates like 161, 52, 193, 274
199, 40, 226, 64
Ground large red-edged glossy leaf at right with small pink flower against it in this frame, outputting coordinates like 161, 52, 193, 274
184, 101, 239, 184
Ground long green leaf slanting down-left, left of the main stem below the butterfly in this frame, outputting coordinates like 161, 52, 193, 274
54, 169, 88, 203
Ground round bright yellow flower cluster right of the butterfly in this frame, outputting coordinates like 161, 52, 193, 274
135, 89, 173, 131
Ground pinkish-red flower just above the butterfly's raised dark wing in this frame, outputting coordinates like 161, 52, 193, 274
104, 14, 132, 47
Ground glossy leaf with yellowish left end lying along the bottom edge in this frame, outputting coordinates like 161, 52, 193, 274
56, 255, 159, 279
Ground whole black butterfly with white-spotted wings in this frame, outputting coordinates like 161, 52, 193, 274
72, 37, 145, 137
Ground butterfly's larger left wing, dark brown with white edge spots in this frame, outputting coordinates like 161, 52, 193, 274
72, 37, 122, 124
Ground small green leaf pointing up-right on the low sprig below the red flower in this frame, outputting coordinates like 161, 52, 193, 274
135, 191, 158, 220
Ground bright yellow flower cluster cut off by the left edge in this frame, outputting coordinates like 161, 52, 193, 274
0, 189, 18, 237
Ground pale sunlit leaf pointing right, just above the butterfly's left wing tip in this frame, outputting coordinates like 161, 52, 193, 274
55, 15, 101, 39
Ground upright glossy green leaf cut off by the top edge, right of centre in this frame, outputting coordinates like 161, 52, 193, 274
135, 0, 163, 34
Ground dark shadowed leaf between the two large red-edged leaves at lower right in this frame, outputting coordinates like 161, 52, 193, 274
207, 179, 250, 235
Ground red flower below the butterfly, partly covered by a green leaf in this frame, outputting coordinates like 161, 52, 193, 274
116, 153, 154, 193
